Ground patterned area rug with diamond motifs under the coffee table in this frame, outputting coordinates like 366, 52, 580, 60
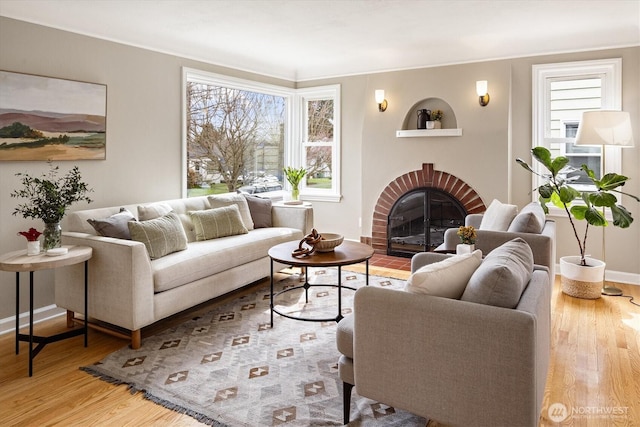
82, 269, 426, 426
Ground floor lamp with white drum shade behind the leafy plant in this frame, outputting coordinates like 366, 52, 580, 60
575, 110, 633, 296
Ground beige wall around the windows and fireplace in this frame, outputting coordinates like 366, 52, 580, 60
0, 18, 640, 319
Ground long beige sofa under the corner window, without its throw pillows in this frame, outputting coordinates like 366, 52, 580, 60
55, 196, 313, 348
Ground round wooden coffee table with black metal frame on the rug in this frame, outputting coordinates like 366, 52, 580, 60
269, 240, 373, 327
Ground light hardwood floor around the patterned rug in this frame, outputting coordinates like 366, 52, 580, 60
0, 267, 640, 427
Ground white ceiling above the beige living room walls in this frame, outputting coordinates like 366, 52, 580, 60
0, 0, 640, 81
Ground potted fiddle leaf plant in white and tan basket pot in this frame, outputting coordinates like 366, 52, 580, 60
516, 147, 640, 299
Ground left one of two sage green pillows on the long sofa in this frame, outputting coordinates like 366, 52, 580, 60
127, 212, 187, 260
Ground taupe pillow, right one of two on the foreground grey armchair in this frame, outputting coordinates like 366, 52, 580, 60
461, 237, 533, 308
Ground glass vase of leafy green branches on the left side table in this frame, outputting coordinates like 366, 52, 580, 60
11, 162, 93, 251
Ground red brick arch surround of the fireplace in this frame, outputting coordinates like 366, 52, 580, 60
362, 163, 487, 254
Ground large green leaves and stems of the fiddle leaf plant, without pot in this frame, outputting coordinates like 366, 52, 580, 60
516, 147, 640, 265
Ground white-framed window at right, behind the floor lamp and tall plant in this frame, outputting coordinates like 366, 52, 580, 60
532, 58, 622, 197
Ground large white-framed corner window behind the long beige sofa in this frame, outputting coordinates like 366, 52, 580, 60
183, 68, 340, 200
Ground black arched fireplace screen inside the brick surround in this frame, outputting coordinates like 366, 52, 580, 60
387, 188, 466, 257
